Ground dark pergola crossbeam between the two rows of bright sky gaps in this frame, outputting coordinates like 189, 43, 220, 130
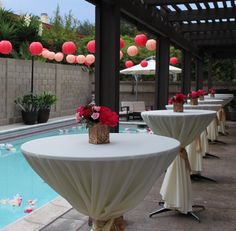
167, 8, 236, 22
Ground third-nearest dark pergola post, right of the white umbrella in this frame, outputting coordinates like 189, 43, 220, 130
181, 50, 192, 94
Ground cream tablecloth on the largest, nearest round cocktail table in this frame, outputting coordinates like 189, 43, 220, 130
21, 134, 180, 230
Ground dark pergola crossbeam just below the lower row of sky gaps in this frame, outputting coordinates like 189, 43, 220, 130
180, 22, 236, 33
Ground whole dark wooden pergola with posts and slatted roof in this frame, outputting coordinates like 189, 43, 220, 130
85, 0, 236, 122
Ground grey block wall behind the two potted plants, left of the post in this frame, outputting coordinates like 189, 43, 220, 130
0, 58, 91, 125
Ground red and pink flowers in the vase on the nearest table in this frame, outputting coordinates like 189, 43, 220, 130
76, 104, 119, 128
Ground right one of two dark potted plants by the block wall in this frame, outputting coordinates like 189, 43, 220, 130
38, 91, 57, 123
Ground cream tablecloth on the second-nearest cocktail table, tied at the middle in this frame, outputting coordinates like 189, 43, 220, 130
141, 110, 216, 213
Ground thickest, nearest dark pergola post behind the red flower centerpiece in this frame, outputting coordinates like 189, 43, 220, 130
95, 1, 120, 113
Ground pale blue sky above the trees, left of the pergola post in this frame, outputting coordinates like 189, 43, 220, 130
0, 0, 95, 23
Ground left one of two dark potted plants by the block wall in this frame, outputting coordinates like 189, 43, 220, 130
15, 94, 39, 125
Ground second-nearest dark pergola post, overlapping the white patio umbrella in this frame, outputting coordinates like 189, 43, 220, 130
154, 36, 170, 109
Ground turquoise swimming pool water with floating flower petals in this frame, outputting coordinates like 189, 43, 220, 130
0, 123, 145, 229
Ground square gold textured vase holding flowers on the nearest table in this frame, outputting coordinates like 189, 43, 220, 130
88, 124, 110, 144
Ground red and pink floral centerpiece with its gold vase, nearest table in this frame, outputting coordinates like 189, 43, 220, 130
76, 104, 119, 144
